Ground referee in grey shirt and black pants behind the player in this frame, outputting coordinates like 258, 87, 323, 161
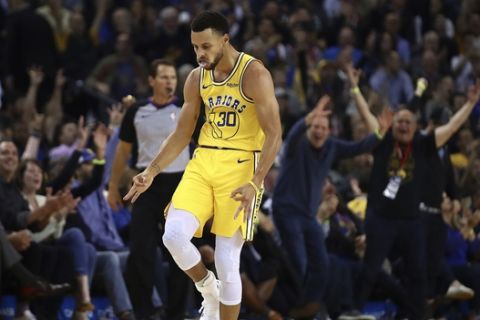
108, 59, 190, 319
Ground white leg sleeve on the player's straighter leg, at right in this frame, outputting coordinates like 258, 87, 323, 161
215, 231, 243, 306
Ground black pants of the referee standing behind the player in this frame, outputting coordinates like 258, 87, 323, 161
126, 172, 189, 320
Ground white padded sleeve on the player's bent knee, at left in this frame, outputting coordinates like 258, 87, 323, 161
162, 205, 201, 271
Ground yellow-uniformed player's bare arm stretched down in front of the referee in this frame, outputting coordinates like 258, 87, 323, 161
124, 68, 201, 202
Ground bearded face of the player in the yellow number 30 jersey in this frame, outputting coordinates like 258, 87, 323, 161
191, 28, 228, 70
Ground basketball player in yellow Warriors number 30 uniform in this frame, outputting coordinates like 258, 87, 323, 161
125, 11, 281, 320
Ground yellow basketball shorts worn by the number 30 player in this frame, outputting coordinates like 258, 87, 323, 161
171, 147, 260, 238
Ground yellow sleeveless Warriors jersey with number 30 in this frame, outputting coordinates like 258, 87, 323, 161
199, 52, 265, 151
